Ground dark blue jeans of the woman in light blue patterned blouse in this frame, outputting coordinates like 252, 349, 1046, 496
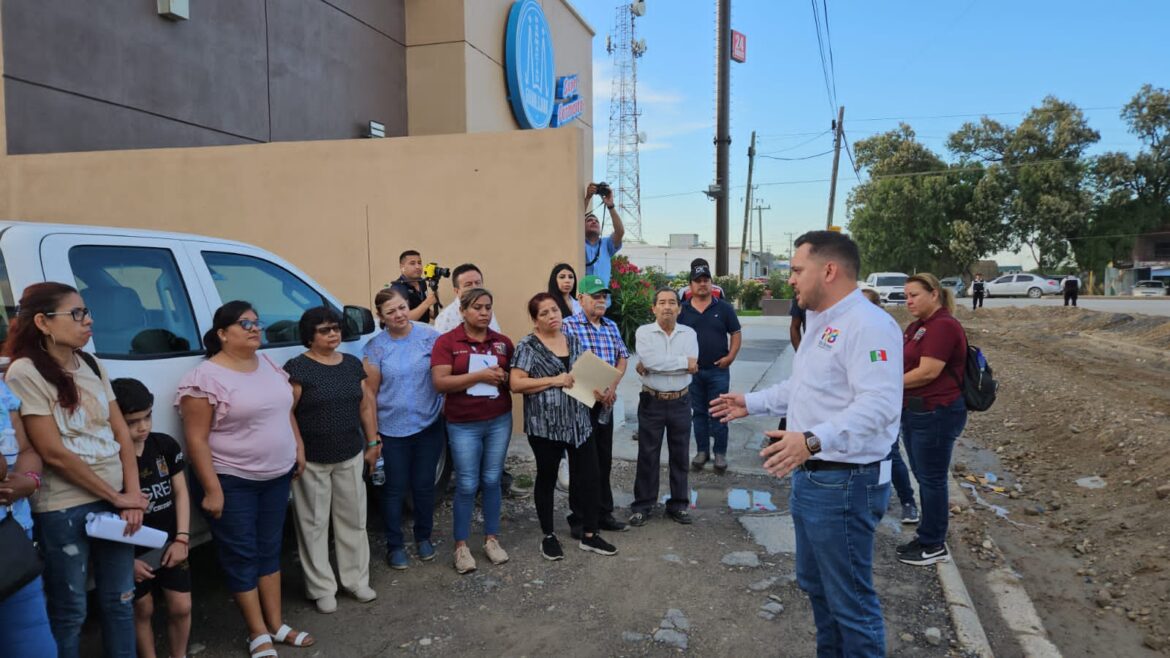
381, 416, 447, 551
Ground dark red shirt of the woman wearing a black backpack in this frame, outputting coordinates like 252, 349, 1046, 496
902, 308, 966, 411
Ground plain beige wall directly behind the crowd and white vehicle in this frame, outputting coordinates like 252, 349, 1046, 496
0, 130, 584, 338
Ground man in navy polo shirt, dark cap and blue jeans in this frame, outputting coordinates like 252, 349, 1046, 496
679, 262, 742, 473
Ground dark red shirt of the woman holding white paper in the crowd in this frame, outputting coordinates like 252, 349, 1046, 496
431, 323, 514, 423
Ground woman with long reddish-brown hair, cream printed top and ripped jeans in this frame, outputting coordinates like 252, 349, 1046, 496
5, 282, 146, 658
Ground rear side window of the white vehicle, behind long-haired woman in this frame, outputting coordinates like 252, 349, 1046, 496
69, 245, 202, 358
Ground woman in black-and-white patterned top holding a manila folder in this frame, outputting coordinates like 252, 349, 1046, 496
510, 293, 618, 560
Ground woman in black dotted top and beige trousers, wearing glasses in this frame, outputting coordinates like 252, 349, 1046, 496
284, 307, 381, 615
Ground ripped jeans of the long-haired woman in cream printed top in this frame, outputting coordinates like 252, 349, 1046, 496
33, 501, 138, 658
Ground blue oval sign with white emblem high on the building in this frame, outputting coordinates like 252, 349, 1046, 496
504, 0, 556, 129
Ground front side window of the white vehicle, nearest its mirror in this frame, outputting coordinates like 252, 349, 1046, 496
204, 252, 329, 345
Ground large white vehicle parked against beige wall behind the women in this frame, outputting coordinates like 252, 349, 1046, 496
0, 221, 376, 534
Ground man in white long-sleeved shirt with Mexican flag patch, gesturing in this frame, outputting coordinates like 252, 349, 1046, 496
711, 231, 902, 656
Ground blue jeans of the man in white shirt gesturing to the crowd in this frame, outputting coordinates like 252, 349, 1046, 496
789, 464, 890, 656
